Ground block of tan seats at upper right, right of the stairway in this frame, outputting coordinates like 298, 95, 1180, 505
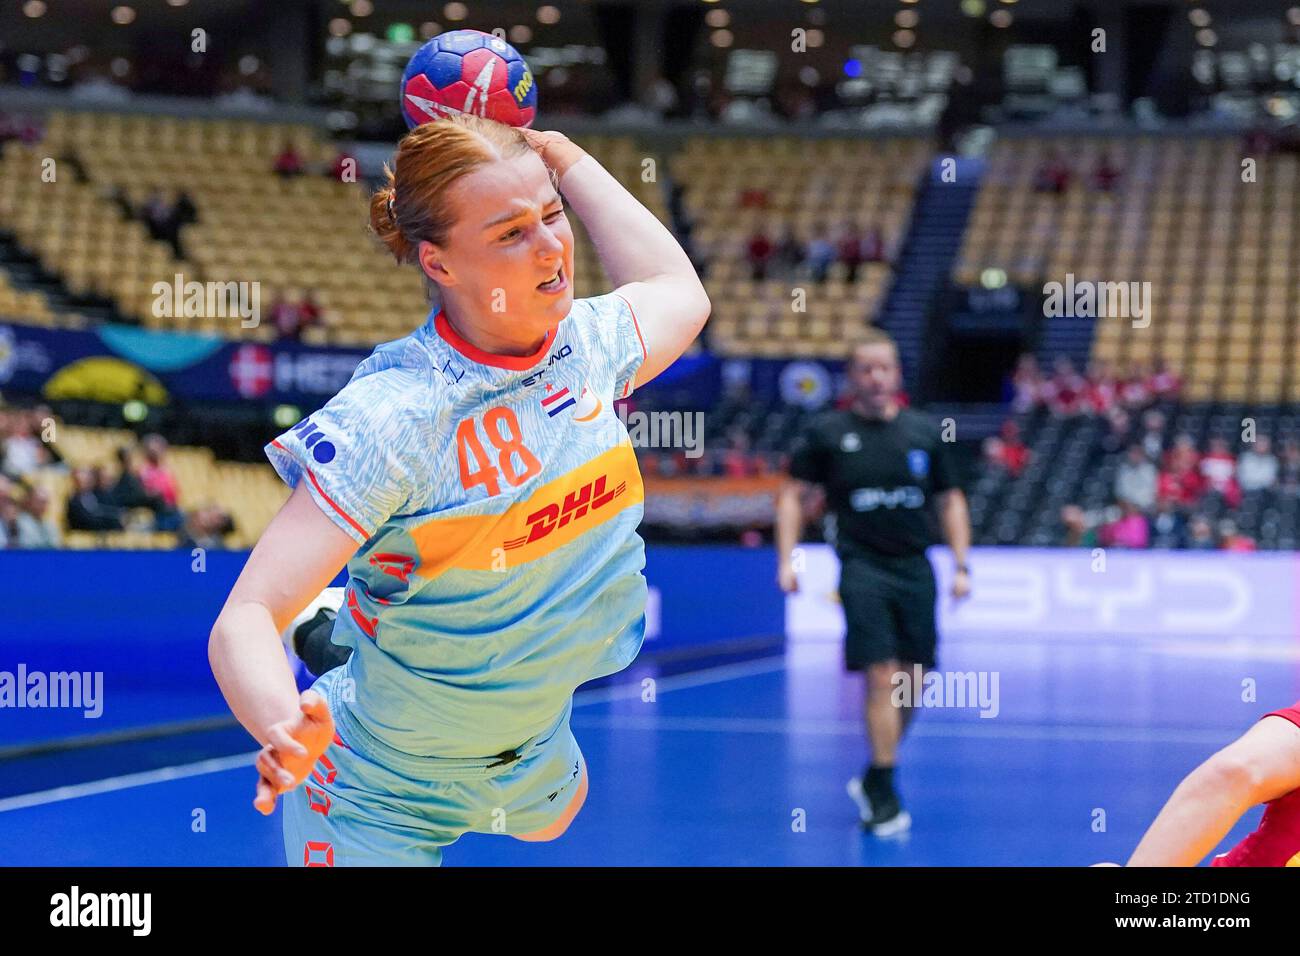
954, 137, 1300, 403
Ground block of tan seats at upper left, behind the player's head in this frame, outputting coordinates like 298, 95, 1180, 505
0, 112, 667, 346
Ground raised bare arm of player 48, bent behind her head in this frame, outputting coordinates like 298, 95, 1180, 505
524, 130, 712, 386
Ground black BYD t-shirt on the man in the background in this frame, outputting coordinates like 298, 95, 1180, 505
790, 408, 957, 558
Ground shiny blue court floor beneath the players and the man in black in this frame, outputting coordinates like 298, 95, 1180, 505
0, 635, 1300, 866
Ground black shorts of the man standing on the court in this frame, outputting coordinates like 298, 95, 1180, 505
840, 554, 939, 670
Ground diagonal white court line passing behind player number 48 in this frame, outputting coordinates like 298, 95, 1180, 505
0, 657, 785, 813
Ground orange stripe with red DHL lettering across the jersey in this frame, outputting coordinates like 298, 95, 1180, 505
411, 442, 645, 579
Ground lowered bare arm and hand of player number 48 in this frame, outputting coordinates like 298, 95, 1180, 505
208, 481, 356, 813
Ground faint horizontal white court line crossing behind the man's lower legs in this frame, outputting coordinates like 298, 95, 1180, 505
579, 714, 1234, 745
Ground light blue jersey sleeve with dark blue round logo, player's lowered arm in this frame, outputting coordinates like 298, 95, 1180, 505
265, 371, 433, 544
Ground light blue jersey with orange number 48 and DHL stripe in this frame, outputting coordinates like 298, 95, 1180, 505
267, 293, 646, 774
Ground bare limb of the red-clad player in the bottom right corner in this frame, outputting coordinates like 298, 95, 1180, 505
1128, 717, 1300, 866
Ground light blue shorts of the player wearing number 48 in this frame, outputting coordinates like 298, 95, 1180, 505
288, 667, 586, 866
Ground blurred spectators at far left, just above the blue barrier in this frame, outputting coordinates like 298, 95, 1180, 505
0, 406, 234, 549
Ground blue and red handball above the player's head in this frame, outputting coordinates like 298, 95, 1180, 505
402, 30, 537, 129
